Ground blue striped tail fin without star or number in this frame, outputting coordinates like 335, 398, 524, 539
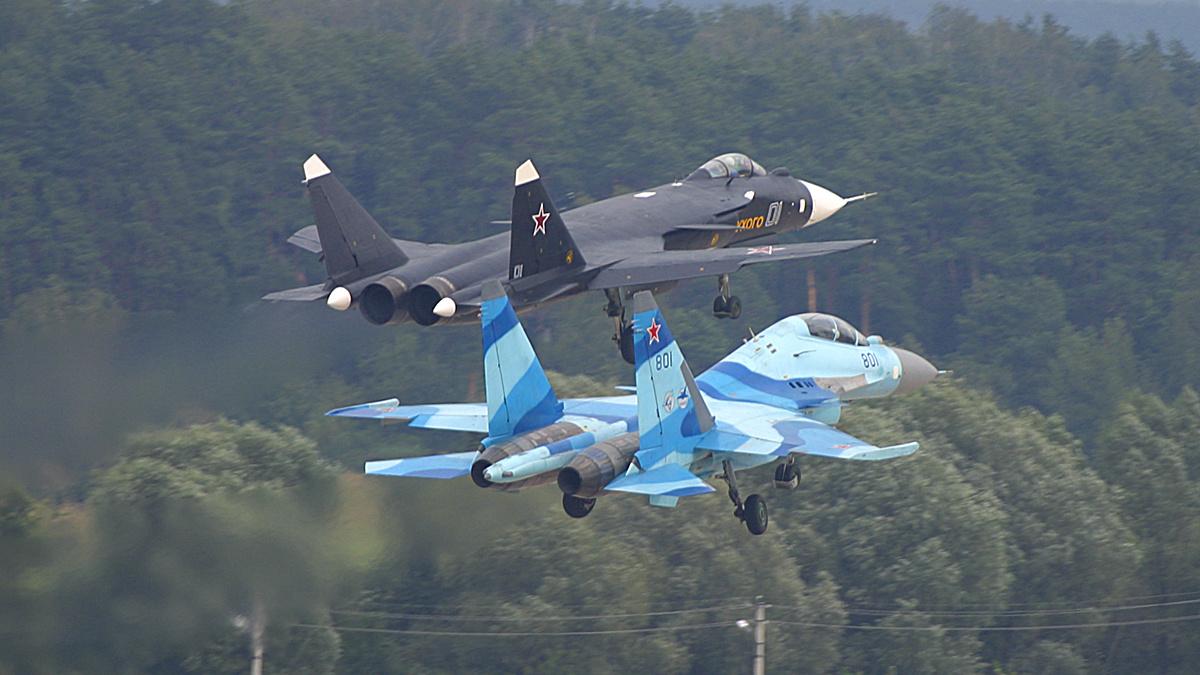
480, 280, 563, 438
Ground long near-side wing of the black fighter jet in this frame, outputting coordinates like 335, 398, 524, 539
588, 239, 876, 289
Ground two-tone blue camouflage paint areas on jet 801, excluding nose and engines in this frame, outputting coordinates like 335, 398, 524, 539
340, 282, 917, 507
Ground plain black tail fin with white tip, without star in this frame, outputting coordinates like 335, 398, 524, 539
304, 155, 408, 286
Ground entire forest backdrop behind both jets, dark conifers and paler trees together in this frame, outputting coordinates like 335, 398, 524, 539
0, 0, 1200, 673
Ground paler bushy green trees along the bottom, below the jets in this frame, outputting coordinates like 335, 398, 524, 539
9, 357, 1200, 673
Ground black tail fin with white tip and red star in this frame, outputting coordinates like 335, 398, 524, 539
509, 160, 583, 280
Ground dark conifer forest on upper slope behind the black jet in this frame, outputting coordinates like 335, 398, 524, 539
0, 0, 1200, 404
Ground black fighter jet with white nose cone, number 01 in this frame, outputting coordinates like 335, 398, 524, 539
264, 153, 875, 363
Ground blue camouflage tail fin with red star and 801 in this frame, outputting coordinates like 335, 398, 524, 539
634, 291, 713, 471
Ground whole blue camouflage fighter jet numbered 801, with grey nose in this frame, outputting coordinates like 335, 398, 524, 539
326, 281, 938, 534
